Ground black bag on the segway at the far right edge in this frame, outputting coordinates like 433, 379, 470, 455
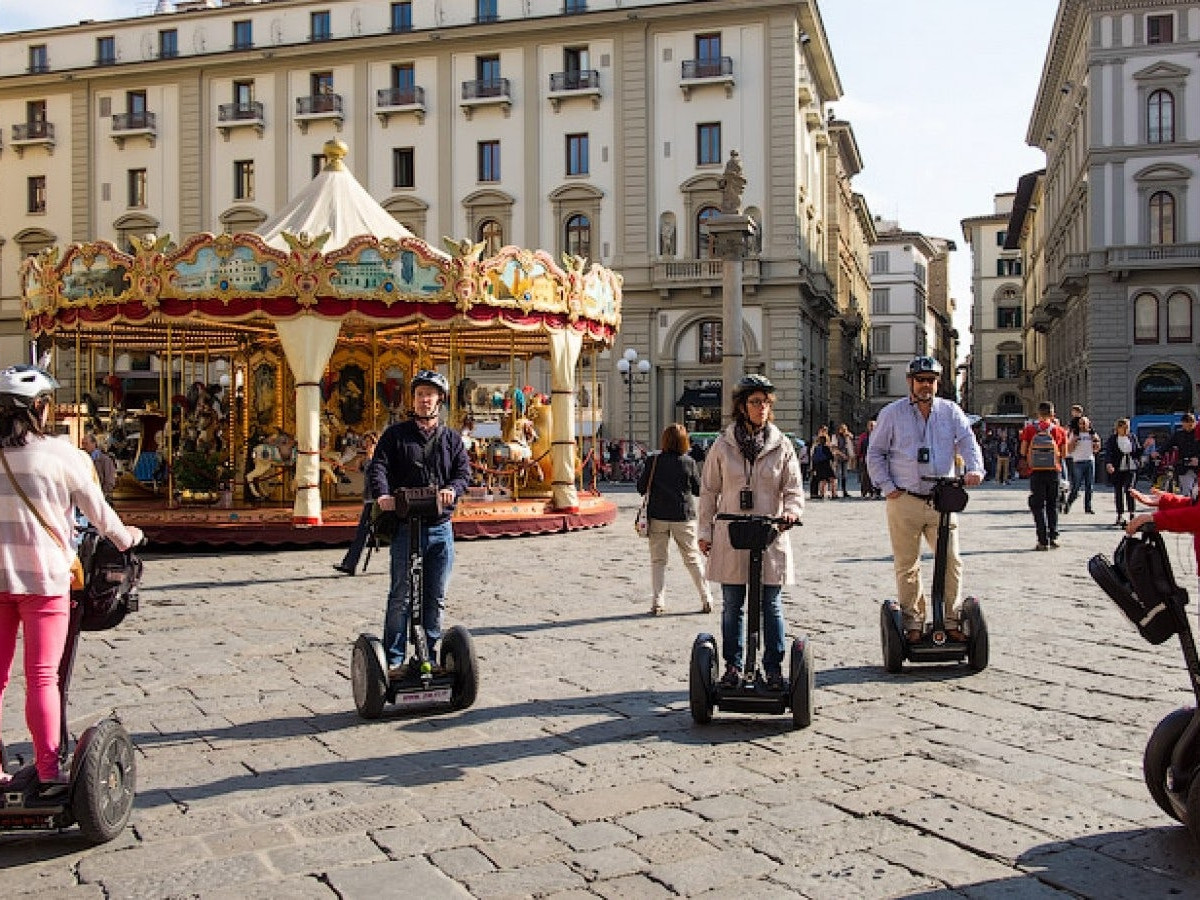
1087, 530, 1188, 644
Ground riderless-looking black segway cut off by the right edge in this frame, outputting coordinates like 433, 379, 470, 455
1087, 523, 1200, 841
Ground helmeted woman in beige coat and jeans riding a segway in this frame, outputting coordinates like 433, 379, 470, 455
697, 374, 804, 689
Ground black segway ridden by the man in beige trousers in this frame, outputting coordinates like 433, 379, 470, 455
880, 475, 988, 674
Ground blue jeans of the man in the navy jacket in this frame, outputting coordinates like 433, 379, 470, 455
383, 521, 454, 667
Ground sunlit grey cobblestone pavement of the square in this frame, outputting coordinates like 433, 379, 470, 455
0, 486, 1200, 900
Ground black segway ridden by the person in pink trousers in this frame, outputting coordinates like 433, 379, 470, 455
0, 526, 142, 844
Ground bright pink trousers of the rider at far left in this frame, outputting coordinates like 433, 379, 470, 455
0, 593, 71, 781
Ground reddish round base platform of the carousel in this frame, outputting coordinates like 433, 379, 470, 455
115, 491, 617, 548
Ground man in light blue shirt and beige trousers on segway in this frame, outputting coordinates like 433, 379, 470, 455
866, 356, 983, 643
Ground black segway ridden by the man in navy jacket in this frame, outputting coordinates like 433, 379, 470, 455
350, 487, 479, 719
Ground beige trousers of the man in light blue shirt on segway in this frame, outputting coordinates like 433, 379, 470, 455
888, 493, 962, 631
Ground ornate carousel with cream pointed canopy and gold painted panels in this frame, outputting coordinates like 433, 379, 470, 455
20, 140, 620, 545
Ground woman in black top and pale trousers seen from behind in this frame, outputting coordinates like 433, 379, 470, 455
637, 422, 713, 616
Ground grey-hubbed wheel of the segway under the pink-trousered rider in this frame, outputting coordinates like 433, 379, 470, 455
71, 719, 137, 844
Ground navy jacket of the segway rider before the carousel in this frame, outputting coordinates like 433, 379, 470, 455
367, 419, 470, 524
